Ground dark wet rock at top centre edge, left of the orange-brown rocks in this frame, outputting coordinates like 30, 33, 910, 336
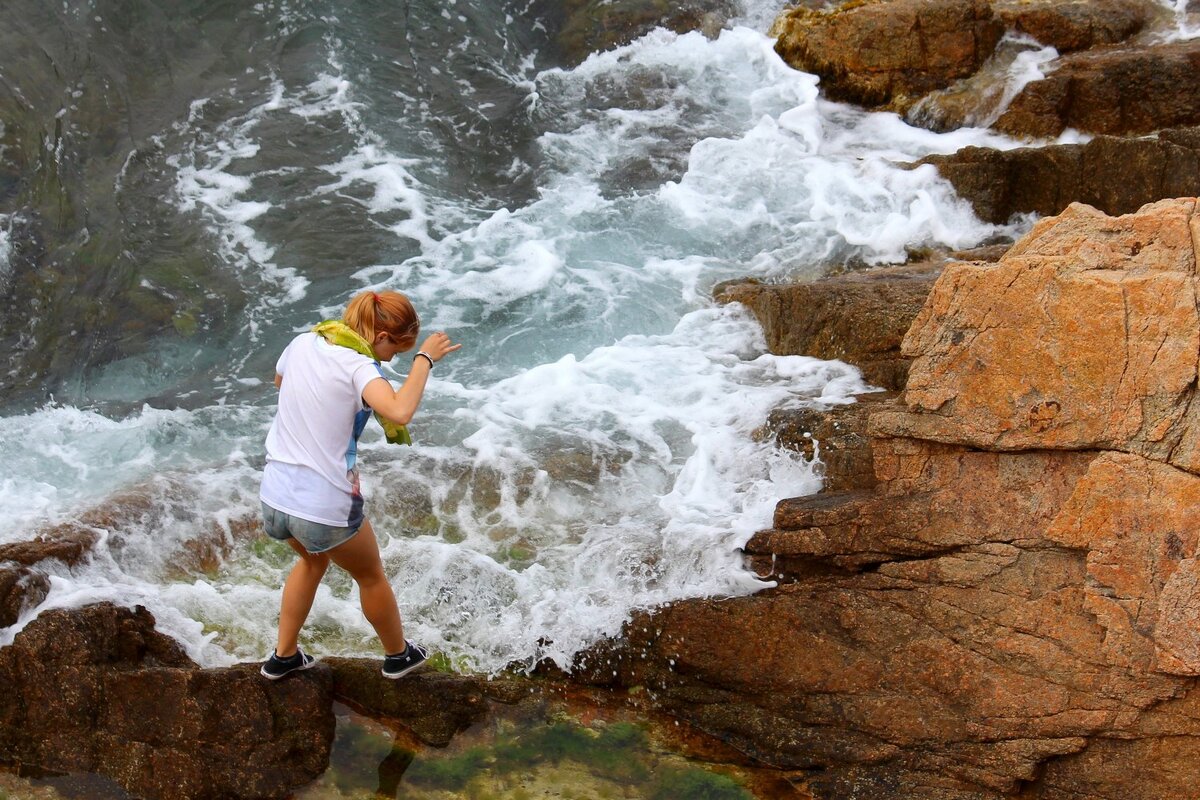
557, 0, 737, 64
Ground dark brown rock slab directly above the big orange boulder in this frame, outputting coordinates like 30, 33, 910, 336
918, 128, 1200, 224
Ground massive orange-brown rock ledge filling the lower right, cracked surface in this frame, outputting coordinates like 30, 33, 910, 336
561, 199, 1200, 800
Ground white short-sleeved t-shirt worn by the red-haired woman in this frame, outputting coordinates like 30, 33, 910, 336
259, 332, 383, 528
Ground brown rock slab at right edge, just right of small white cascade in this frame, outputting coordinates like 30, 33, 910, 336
994, 40, 1200, 137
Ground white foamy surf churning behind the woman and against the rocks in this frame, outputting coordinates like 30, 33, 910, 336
0, 3, 1032, 670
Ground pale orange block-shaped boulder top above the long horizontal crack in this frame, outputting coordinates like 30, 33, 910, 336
872, 199, 1200, 470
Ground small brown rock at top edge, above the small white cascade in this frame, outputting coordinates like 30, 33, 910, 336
992, 0, 1163, 53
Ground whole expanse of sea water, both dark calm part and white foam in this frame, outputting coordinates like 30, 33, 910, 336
0, 0, 1032, 672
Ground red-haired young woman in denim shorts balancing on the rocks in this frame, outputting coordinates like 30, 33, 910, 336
260, 291, 462, 680
